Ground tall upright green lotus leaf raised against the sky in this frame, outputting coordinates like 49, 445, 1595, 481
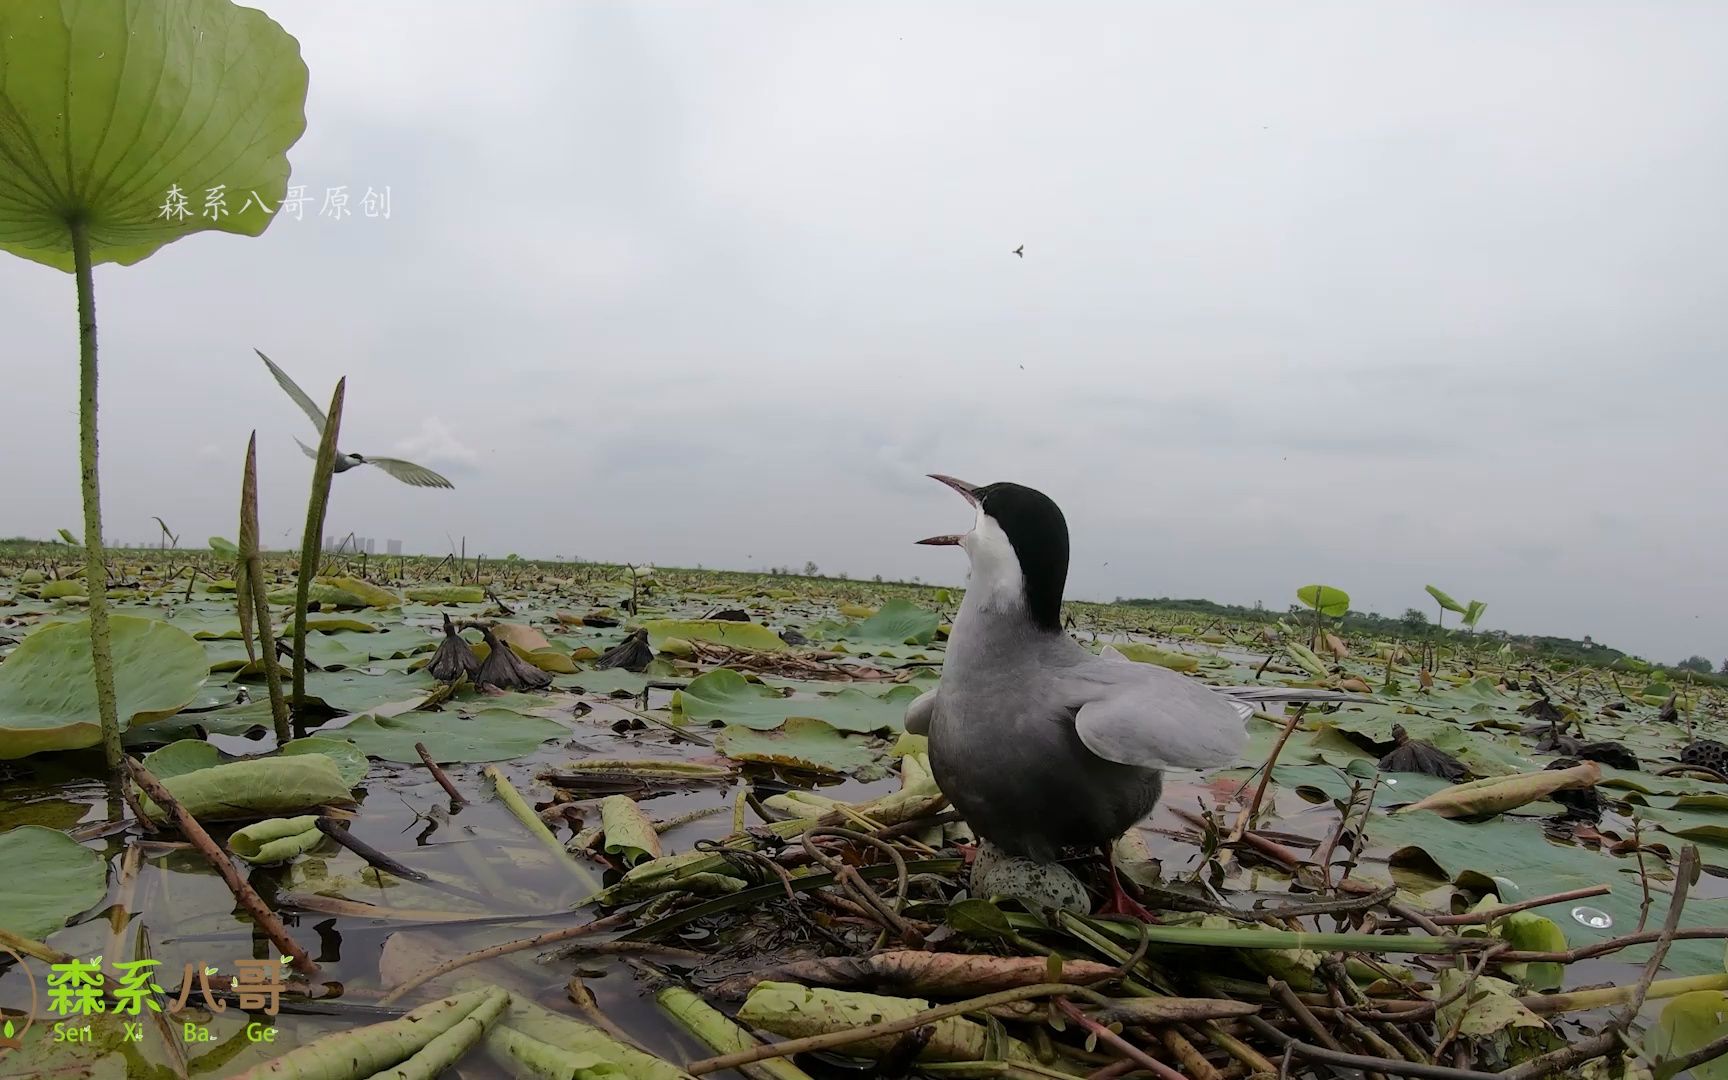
0, 0, 306, 271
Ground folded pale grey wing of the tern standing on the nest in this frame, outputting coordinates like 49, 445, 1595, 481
1073, 658, 1253, 769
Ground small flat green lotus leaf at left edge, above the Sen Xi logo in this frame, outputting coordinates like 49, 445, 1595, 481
0, 824, 107, 938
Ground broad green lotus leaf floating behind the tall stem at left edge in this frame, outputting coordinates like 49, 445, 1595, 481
0, 615, 209, 759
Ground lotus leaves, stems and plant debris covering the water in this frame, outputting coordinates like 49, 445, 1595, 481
0, 546, 1728, 1080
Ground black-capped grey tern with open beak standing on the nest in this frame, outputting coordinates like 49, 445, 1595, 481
905, 473, 1365, 918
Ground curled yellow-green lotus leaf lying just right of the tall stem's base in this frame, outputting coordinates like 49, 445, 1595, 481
143, 753, 354, 821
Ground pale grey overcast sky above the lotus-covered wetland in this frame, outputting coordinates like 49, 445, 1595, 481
0, 0, 1728, 660
